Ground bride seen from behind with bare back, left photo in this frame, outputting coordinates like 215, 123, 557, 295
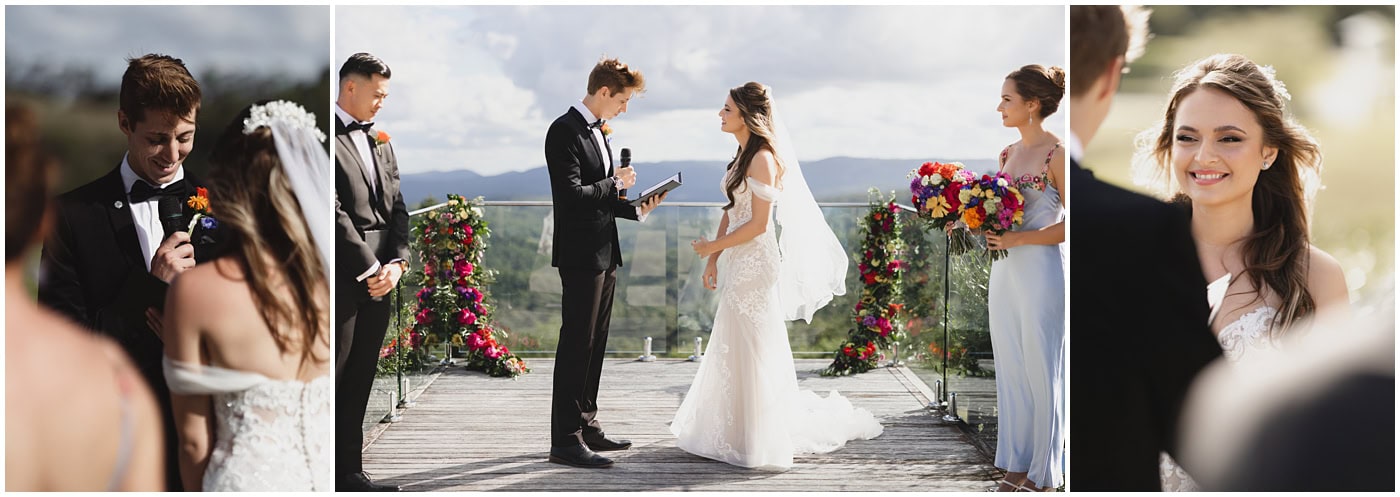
165, 101, 330, 491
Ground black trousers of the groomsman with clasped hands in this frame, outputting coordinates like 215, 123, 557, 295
335, 277, 393, 475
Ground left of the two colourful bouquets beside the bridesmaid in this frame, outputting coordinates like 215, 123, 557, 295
909, 162, 977, 253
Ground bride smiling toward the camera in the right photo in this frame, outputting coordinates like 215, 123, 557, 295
1135, 55, 1350, 490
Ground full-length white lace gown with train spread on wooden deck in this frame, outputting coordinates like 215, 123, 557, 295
671, 178, 883, 469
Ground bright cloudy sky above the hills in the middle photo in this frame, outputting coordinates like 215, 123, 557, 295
333, 6, 1065, 175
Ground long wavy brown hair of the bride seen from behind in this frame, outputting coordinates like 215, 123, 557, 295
209, 101, 330, 364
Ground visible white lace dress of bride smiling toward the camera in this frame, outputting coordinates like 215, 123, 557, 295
1159, 274, 1278, 491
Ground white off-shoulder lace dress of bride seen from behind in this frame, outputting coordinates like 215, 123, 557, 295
164, 357, 330, 491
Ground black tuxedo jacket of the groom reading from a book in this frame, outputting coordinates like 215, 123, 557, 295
545, 108, 637, 270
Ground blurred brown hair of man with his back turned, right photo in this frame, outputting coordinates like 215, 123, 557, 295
1070, 6, 1152, 95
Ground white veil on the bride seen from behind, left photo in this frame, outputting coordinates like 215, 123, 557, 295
244, 101, 332, 281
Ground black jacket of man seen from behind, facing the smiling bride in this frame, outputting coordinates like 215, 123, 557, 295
1070, 162, 1221, 491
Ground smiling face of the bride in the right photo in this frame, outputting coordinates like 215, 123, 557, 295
1170, 87, 1278, 206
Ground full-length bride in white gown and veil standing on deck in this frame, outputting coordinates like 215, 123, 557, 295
671, 83, 883, 469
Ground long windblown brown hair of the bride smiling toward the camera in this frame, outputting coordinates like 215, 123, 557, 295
1134, 53, 1322, 330
